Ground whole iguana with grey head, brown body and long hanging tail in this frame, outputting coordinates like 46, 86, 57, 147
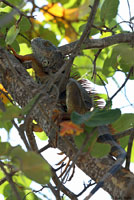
9, 38, 126, 198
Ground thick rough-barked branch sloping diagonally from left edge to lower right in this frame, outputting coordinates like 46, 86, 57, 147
0, 48, 134, 199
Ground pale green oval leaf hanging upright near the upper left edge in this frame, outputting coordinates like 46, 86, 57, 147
5, 25, 20, 45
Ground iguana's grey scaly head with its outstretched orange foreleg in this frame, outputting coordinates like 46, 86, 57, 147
8, 37, 64, 79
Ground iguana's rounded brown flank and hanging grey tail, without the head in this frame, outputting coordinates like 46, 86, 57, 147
66, 79, 126, 199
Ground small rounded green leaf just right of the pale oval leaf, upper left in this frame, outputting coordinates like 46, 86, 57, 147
19, 17, 31, 33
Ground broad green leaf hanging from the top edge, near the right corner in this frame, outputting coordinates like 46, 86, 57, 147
100, 0, 119, 22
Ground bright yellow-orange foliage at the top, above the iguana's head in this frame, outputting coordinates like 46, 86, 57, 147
41, 0, 90, 42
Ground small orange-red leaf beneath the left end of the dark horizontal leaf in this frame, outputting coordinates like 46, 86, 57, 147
60, 121, 84, 136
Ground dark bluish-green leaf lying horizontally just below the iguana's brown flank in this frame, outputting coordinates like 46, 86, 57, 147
71, 109, 121, 127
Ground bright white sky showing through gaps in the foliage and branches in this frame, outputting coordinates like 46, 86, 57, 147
0, 0, 134, 200
